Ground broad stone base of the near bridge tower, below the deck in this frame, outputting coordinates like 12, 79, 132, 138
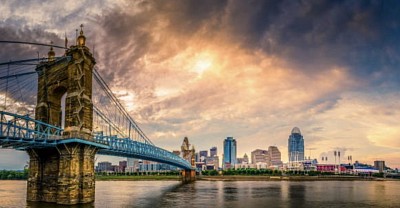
27, 143, 97, 205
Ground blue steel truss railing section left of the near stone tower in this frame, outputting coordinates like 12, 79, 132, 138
0, 111, 63, 141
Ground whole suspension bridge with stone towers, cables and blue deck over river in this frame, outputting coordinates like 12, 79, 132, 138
0, 27, 195, 204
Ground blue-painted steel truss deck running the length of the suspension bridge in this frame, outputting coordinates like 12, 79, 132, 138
0, 111, 192, 170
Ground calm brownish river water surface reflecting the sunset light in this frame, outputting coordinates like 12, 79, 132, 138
0, 181, 400, 208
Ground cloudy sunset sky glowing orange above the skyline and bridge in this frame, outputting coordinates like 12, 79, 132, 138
0, 0, 400, 169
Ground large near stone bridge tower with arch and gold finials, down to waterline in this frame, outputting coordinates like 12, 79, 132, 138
27, 25, 97, 204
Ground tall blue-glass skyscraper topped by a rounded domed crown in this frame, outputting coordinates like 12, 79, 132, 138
288, 127, 304, 163
